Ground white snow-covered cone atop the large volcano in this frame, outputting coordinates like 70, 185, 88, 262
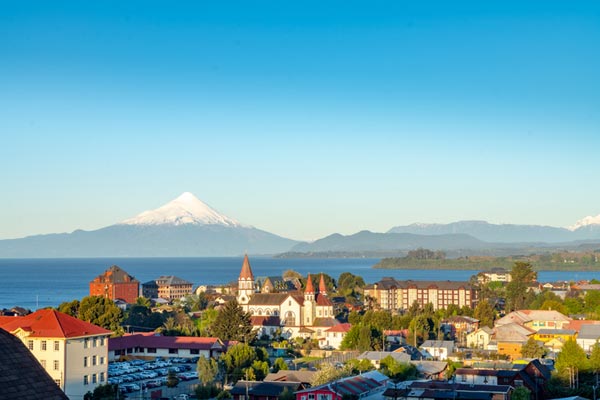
121, 192, 247, 227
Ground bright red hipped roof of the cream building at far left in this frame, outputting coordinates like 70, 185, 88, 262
0, 309, 112, 338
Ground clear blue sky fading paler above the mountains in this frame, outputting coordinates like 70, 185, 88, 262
0, 0, 600, 239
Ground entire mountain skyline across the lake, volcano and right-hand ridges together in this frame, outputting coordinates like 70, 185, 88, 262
0, 192, 600, 258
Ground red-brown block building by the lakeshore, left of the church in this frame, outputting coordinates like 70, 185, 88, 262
90, 265, 140, 303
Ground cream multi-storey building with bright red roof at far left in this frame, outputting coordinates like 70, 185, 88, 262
1, 309, 112, 399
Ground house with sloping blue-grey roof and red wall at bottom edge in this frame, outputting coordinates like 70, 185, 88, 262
296, 371, 389, 400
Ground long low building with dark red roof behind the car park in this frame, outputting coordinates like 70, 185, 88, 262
108, 333, 228, 361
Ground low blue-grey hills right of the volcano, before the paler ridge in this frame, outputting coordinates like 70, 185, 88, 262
290, 231, 489, 253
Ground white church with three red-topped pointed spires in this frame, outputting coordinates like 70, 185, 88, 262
237, 255, 339, 339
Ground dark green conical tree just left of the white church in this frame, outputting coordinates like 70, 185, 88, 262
212, 300, 255, 343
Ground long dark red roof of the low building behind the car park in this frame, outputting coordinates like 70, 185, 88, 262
108, 333, 225, 351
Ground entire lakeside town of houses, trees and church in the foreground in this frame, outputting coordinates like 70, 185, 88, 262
0, 256, 600, 400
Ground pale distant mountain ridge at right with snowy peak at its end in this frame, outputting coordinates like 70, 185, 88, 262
388, 220, 600, 243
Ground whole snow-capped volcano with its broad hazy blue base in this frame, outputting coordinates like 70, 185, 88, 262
0, 193, 298, 257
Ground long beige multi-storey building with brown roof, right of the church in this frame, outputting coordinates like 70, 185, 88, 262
364, 277, 477, 311
